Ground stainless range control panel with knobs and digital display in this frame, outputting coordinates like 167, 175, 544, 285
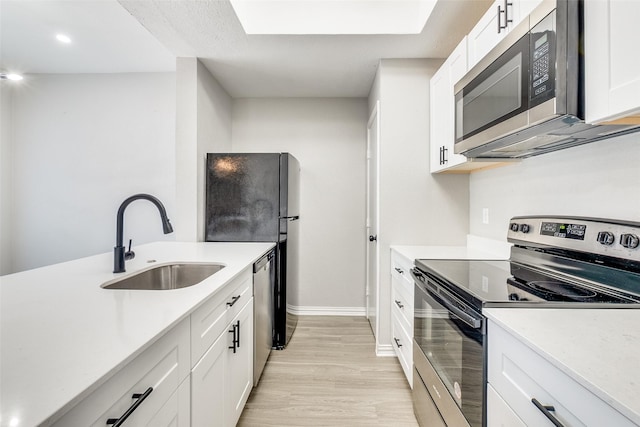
507, 216, 640, 261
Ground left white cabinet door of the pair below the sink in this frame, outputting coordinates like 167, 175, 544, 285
191, 331, 231, 427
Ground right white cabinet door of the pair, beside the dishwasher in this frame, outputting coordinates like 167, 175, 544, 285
225, 298, 253, 426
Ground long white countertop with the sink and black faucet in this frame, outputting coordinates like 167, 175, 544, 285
0, 242, 274, 427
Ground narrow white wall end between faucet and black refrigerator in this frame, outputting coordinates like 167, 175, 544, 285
174, 58, 231, 241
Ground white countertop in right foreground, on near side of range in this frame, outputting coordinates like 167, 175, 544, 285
483, 308, 640, 425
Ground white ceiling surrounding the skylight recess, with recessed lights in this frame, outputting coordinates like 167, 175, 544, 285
0, 0, 492, 98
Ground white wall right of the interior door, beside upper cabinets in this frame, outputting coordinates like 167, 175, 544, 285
369, 59, 469, 352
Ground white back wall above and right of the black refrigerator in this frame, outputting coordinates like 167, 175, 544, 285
232, 98, 368, 312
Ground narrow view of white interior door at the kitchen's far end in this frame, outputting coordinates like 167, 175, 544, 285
365, 101, 380, 336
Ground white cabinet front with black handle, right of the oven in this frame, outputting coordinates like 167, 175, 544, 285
487, 321, 635, 427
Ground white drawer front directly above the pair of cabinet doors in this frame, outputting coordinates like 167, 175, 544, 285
191, 268, 253, 366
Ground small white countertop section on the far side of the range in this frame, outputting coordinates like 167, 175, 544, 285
391, 235, 511, 261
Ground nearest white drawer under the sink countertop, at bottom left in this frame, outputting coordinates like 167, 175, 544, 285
54, 319, 190, 427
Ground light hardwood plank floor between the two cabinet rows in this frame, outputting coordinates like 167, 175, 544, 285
238, 316, 418, 427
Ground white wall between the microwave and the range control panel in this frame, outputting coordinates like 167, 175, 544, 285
470, 133, 640, 241
